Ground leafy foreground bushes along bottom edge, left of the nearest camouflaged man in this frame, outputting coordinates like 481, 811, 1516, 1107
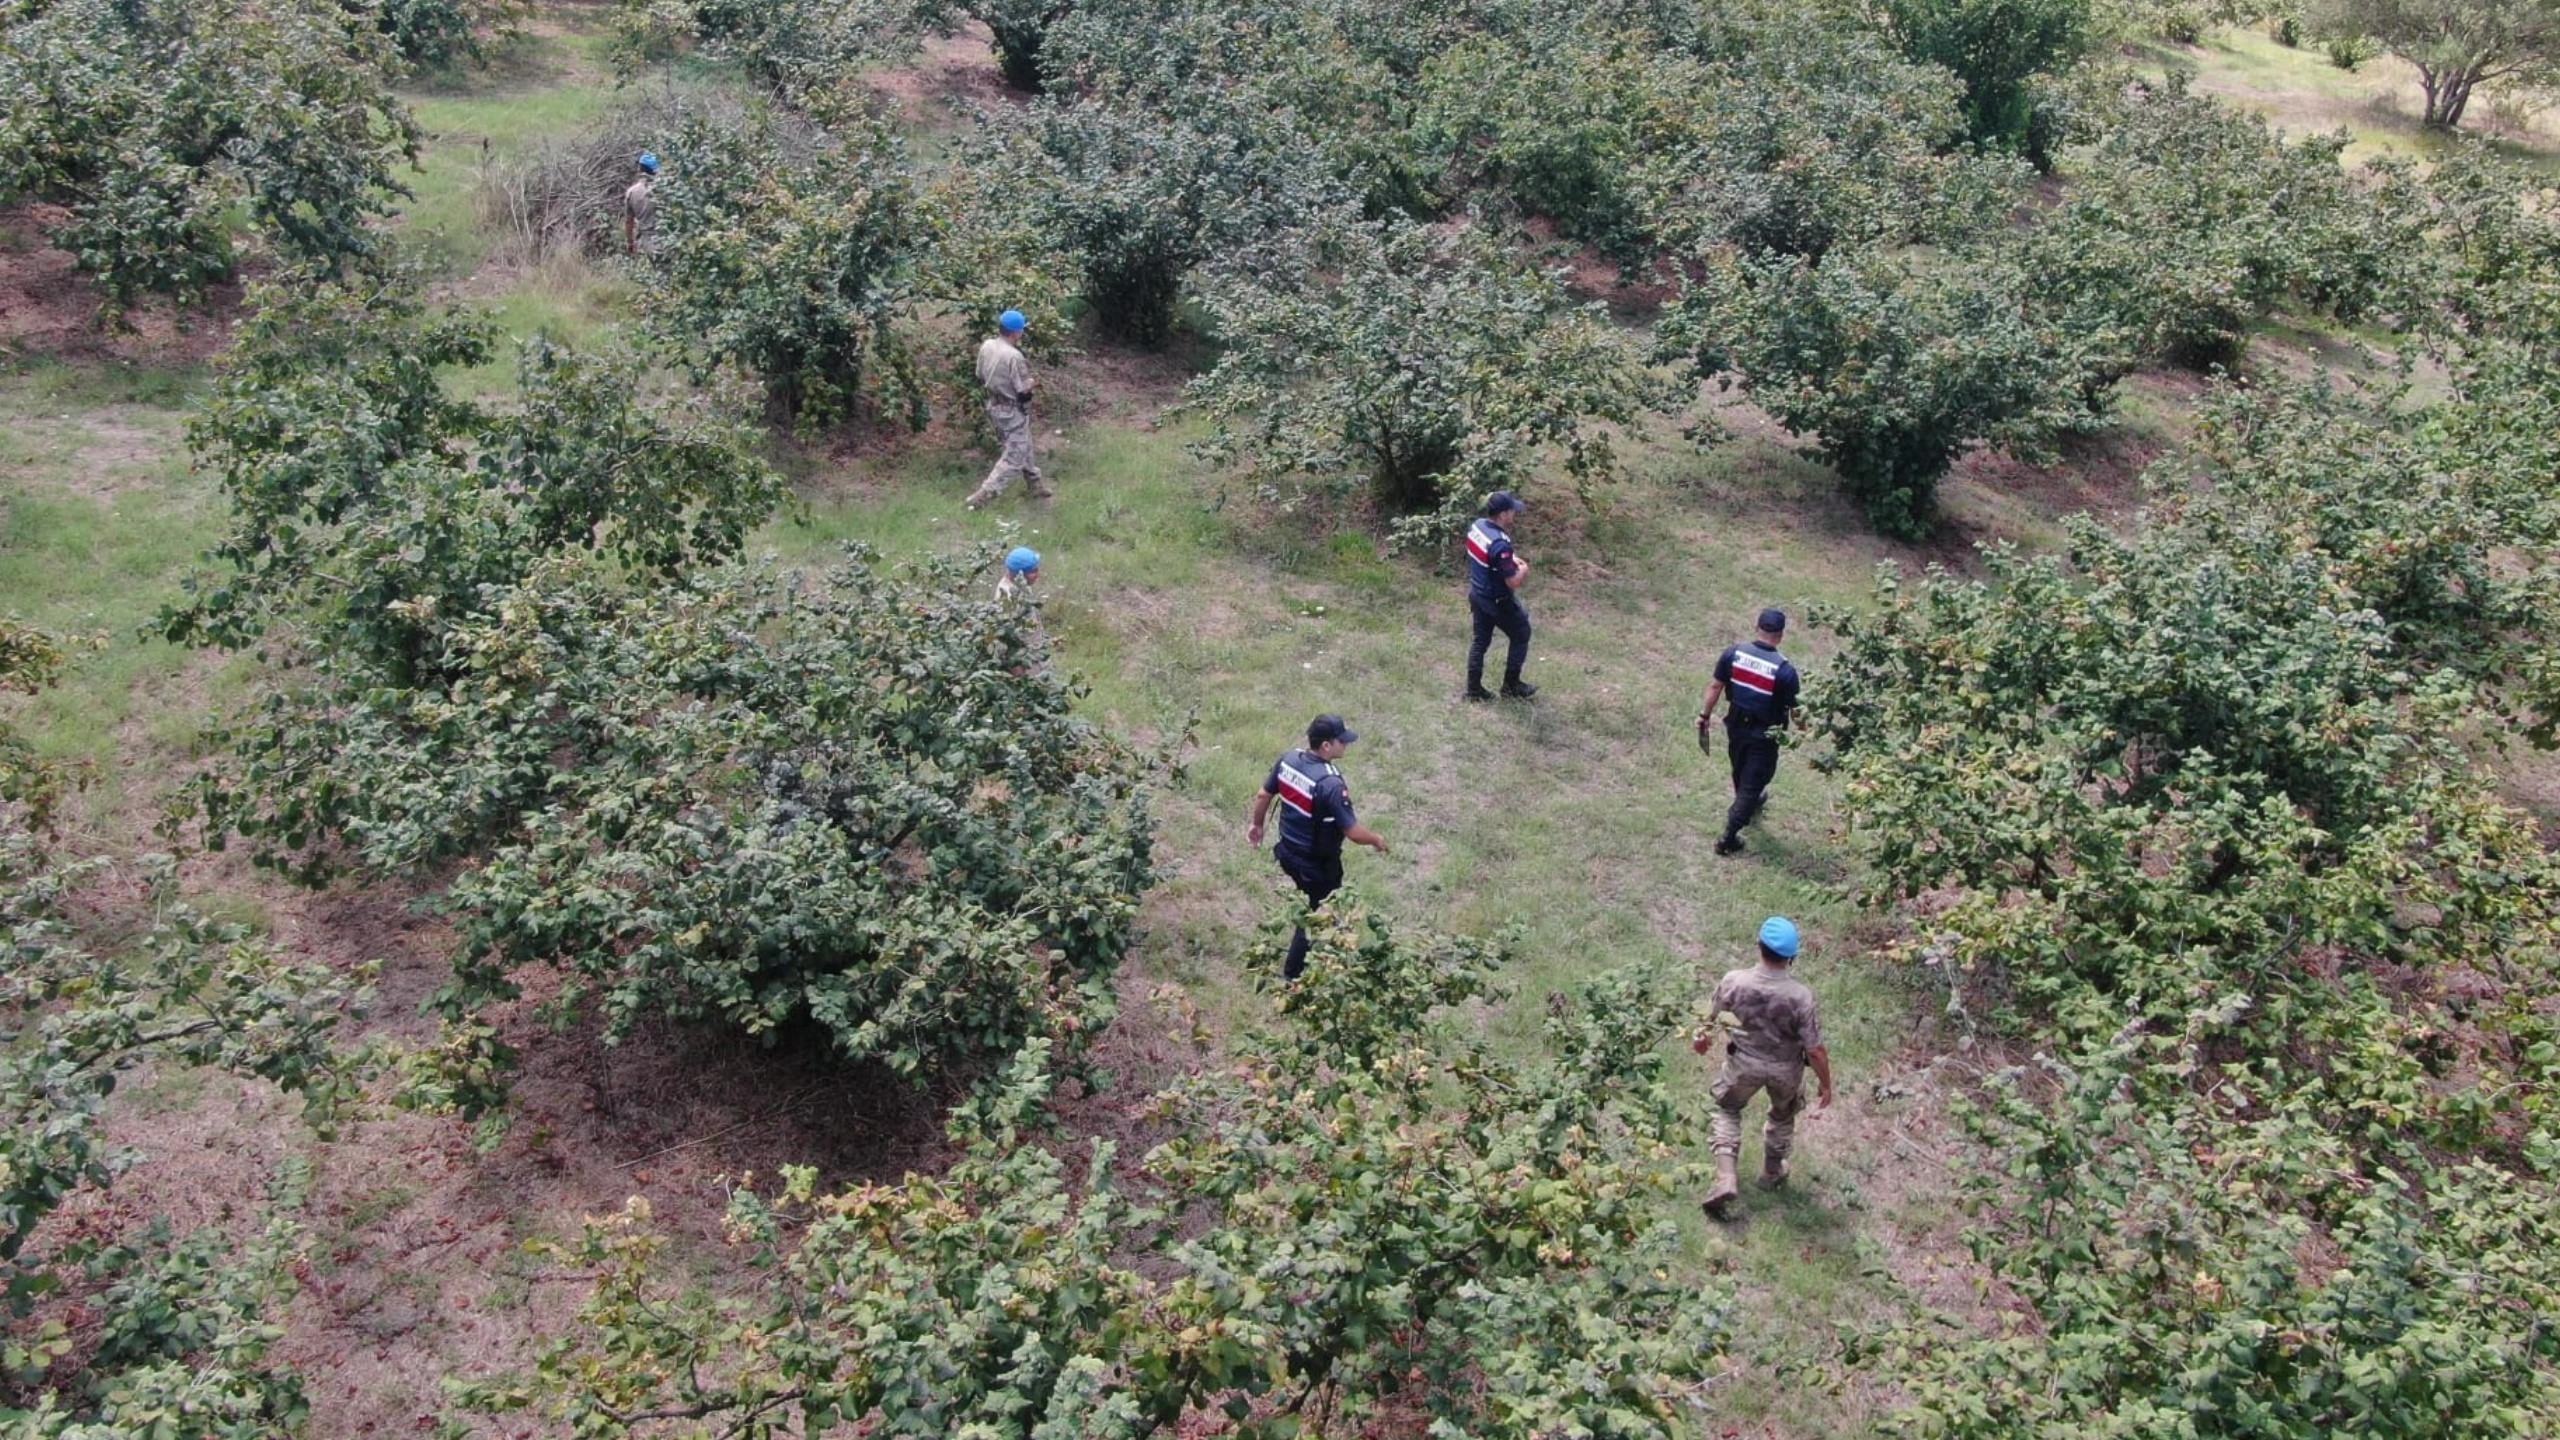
463, 907, 1720, 1440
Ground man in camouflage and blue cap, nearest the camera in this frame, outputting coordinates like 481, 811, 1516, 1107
1690, 915, 1830, 1220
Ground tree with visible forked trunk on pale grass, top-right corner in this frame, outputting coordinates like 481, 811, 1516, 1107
2312, 0, 2560, 131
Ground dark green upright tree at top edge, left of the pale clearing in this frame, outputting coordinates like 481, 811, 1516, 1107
1874, 0, 2094, 159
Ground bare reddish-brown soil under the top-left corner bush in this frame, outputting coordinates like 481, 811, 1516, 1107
0, 202, 241, 366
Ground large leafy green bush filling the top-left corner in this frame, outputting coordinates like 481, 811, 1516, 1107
0, 0, 417, 320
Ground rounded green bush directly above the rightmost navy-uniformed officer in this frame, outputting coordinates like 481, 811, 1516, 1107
1661, 251, 2089, 538
